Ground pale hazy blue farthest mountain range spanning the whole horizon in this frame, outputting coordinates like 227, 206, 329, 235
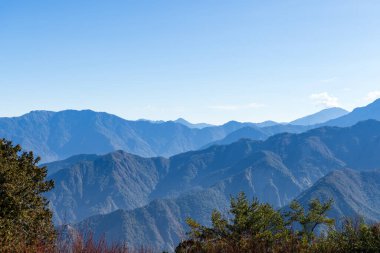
4, 101, 380, 162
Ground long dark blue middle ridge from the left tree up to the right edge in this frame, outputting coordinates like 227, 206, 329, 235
47, 121, 380, 226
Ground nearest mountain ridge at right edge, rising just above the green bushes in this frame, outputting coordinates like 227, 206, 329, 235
297, 167, 380, 226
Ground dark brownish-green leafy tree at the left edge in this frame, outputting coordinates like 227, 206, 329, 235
0, 139, 55, 252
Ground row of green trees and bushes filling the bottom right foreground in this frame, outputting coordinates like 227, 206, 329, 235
176, 193, 380, 253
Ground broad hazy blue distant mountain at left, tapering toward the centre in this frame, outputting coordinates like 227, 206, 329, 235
0, 110, 246, 162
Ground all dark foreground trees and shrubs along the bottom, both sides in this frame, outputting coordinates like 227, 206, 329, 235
0, 140, 380, 253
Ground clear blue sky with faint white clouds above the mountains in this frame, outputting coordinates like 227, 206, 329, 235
0, 0, 380, 123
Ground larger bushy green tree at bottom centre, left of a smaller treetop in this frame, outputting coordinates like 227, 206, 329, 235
177, 193, 288, 252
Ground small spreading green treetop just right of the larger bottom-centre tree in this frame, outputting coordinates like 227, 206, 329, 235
285, 199, 334, 242
